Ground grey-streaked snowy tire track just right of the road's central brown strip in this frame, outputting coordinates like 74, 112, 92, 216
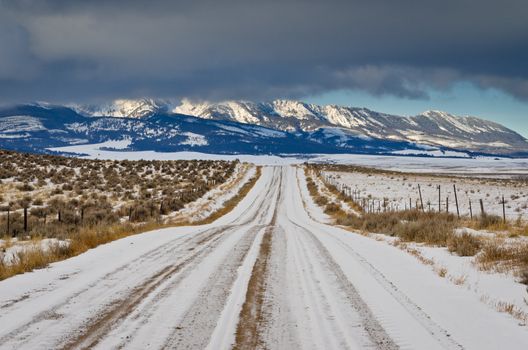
280, 170, 398, 350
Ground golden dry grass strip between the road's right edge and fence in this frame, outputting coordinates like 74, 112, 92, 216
305, 167, 528, 285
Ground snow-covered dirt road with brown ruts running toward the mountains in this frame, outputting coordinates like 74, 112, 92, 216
0, 166, 528, 349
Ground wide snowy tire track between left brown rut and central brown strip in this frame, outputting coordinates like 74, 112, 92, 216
88, 166, 277, 348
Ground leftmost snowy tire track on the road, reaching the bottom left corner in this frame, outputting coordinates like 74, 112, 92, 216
0, 168, 276, 348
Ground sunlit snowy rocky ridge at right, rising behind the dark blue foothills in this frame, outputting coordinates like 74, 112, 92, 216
174, 100, 528, 153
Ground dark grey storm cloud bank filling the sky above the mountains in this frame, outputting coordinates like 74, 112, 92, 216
0, 0, 528, 101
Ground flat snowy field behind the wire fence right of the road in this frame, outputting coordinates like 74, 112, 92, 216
324, 171, 528, 220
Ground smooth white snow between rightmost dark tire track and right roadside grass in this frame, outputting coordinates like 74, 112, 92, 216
296, 168, 528, 349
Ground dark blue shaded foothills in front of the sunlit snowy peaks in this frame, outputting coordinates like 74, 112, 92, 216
0, 105, 420, 154
